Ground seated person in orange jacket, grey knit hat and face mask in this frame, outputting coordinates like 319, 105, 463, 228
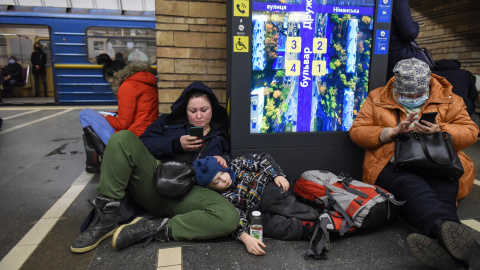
350, 58, 480, 270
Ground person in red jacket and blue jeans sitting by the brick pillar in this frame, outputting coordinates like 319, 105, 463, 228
79, 54, 159, 172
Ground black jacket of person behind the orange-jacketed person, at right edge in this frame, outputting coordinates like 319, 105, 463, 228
432, 59, 478, 115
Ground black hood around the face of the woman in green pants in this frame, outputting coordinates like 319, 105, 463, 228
165, 82, 228, 131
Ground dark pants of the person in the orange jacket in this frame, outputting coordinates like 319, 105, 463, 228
375, 163, 460, 237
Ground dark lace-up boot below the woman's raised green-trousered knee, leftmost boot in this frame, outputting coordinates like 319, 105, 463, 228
70, 196, 120, 253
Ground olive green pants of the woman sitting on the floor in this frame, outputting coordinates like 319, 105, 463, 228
97, 130, 239, 241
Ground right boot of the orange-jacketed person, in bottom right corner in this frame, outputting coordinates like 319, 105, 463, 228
439, 221, 480, 270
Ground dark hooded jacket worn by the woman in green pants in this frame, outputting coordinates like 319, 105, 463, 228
140, 82, 230, 164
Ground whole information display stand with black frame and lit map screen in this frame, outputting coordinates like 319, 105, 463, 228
227, 0, 392, 178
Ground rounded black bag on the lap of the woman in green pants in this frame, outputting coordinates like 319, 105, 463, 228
155, 161, 195, 199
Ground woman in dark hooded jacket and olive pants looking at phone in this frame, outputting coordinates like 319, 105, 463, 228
71, 82, 239, 253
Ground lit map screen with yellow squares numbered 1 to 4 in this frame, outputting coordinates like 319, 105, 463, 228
250, 0, 375, 133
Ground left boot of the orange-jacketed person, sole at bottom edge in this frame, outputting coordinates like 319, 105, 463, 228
407, 233, 465, 270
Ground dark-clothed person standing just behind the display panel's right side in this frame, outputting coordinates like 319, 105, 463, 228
387, 0, 420, 81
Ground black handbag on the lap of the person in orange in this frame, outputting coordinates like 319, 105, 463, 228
394, 132, 464, 181
